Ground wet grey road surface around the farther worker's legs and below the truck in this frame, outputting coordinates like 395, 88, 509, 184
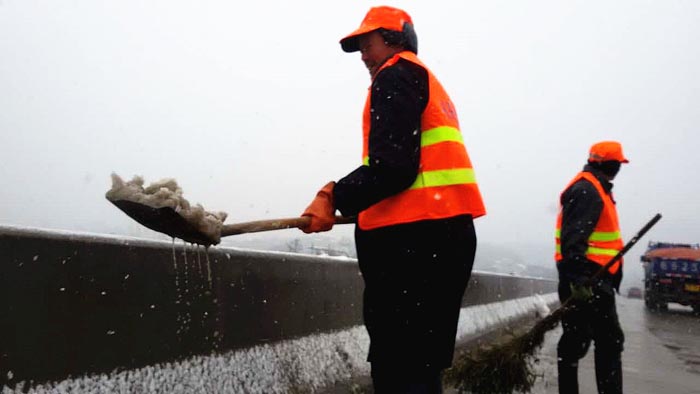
532, 297, 700, 394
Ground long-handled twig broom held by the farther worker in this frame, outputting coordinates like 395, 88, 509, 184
444, 213, 661, 394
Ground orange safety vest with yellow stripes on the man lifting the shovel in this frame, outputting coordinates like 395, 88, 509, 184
358, 51, 486, 230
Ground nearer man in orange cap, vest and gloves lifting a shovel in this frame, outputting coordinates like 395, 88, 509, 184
302, 7, 485, 394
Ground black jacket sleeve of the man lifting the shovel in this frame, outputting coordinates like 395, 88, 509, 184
334, 60, 429, 216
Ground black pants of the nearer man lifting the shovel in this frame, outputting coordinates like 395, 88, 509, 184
355, 215, 476, 393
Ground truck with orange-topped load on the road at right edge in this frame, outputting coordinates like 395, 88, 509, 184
641, 241, 700, 313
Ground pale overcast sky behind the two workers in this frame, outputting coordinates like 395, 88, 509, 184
0, 0, 700, 284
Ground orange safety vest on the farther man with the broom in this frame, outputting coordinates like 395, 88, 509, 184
554, 172, 624, 275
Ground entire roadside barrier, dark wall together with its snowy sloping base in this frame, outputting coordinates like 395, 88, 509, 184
0, 226, 556, 393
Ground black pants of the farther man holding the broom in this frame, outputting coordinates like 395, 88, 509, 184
557, 282, 625, 394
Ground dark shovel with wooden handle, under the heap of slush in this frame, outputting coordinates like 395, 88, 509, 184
107, 198, 355, 246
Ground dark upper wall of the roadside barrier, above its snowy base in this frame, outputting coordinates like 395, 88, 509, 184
0, 226, 556, 392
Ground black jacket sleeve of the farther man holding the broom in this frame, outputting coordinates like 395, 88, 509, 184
557, 179, 603, 283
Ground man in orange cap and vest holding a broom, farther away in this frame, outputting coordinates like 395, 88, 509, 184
555, 141, 628, 394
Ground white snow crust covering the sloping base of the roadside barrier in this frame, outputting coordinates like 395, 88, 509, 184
2, 294, 556, 394
